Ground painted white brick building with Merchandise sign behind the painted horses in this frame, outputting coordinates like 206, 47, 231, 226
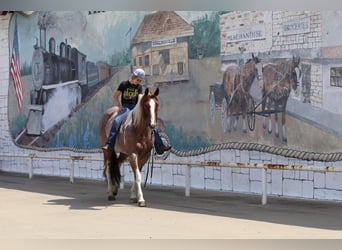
220, 11, 342, 115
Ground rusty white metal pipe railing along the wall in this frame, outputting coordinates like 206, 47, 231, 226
0, 154, 342, 205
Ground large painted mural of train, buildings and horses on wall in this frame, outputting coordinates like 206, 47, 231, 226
8, 11, 342, 156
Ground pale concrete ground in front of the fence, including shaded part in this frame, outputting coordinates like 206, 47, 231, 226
0, 172, 342, 239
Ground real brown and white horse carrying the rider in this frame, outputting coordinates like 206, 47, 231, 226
100, 88, 159, 207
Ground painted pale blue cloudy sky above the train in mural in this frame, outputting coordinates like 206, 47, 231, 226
9, 11, 211, 63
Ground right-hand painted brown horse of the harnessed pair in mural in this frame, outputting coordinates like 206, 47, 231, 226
262, 56, 301, 142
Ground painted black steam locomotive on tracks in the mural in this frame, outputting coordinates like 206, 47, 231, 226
26, 27, 114, 135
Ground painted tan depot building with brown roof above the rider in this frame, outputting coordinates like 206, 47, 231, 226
131, 11, 194, 83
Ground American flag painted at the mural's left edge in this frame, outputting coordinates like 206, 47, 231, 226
11, 19, 23, 113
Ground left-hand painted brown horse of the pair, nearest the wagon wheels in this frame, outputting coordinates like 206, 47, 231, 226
222, 54, 262, 133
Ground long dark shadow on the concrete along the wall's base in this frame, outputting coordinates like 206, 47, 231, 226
0, 172, 342, 230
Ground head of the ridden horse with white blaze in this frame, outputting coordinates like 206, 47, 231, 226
141, 88, 159, 128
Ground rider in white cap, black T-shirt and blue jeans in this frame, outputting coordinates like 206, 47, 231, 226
102, 69, 171, 154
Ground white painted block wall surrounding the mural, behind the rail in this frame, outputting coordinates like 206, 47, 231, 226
0, 12, 342, 201
